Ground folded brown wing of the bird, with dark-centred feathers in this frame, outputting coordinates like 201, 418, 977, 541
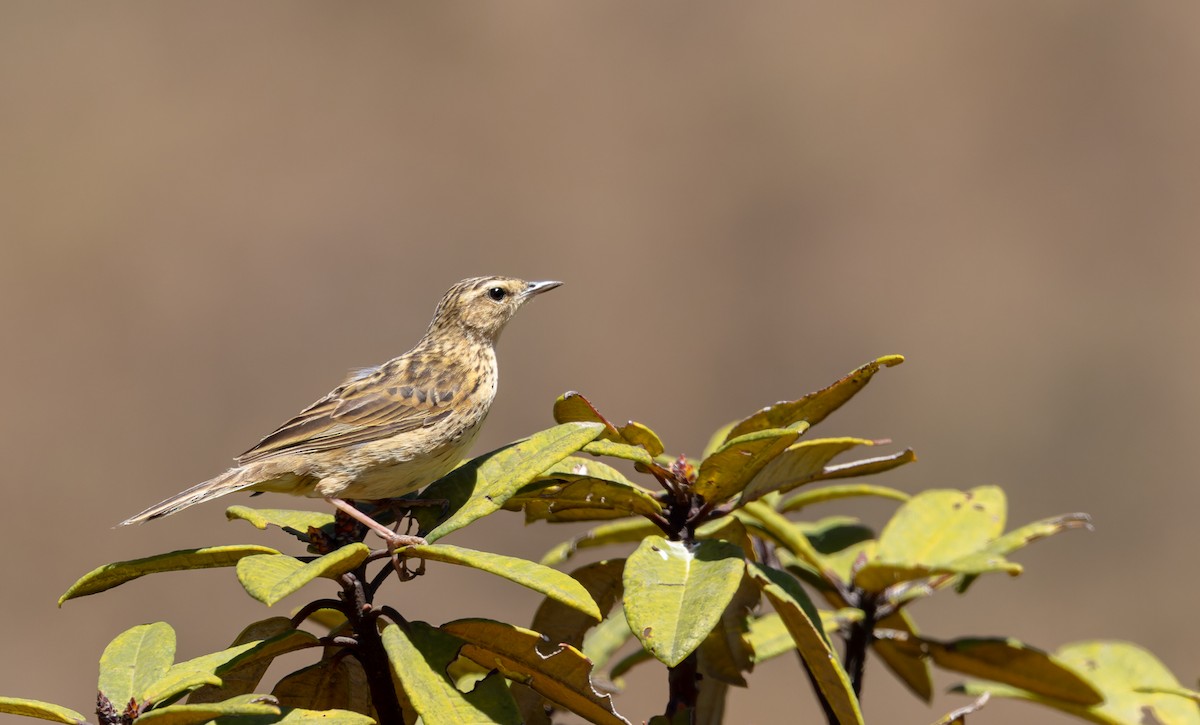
236, 358, 457, 466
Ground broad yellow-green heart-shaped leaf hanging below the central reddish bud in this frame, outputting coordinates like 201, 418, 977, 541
624, 537, 745, 667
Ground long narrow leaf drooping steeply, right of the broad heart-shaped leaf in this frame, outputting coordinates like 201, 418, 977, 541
748, 563, 863, 725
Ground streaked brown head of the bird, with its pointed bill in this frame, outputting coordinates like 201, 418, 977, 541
430, 277, 562, 342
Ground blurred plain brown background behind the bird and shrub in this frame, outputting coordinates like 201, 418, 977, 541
0, 5, 1200, 724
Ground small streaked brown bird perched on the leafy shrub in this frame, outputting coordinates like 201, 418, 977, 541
120, 277, 562, 543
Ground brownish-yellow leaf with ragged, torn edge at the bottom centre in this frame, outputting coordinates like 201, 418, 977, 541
442, 619, 629, 725
